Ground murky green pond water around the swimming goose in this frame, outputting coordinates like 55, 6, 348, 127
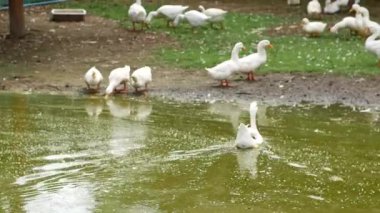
0, 94, 380, 212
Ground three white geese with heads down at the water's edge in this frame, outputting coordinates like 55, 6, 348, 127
84, 65, 152, 97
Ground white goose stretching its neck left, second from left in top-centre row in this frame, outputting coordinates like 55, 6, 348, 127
146, 5, 189, 27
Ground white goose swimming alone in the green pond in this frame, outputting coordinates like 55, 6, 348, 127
235, 101, 264, 149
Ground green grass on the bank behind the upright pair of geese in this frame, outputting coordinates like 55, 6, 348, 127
63, 0, 379, 75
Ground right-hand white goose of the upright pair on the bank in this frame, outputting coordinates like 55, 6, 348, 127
239, 40, 273, 81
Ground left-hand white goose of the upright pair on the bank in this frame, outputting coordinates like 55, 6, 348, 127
206, 42, 244, 87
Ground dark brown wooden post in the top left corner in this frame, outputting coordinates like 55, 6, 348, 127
9, 0, 26, 38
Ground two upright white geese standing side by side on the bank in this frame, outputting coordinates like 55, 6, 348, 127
206, 40, 272, 87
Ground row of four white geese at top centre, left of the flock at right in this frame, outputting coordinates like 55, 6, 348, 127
128, 0, 227, 30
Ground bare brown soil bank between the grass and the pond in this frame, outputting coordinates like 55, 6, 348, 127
0, 7, 380, 106
